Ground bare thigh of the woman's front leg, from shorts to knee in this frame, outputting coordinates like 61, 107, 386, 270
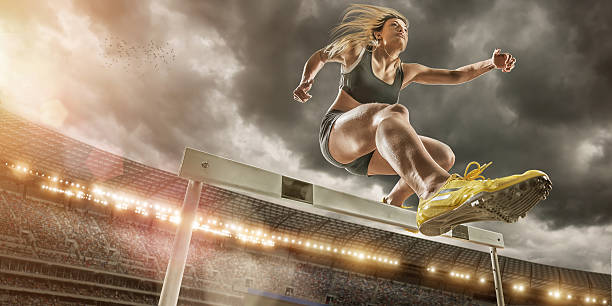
329, 103, 389, 164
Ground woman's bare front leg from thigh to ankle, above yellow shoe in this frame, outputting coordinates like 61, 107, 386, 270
329, 103, 450, 198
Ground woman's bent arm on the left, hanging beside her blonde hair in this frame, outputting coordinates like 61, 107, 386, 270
293, 47, 355, 103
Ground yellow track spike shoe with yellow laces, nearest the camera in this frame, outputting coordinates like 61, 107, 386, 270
416, 162, 552, 236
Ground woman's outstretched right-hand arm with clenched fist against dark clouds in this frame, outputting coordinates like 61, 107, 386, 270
402, 49, 516, 86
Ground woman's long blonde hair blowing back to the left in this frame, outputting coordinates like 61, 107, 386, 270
324, 4, 408, 65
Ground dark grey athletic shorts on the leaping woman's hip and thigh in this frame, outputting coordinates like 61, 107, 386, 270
319, 109, 374, 177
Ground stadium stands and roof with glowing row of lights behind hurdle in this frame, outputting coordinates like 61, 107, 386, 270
0, 104, 611, 305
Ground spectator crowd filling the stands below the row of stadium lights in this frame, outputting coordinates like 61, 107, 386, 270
0, 189, 488, 305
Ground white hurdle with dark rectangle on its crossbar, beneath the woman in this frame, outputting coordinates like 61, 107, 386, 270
159, 148, 504, 306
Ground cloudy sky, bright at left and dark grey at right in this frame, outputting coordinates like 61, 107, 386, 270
0, 0, 612, 273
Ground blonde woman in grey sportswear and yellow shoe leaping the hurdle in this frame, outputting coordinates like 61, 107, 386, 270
293, 4, 552, 235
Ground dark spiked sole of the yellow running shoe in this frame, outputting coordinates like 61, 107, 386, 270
419, 175, 552, 236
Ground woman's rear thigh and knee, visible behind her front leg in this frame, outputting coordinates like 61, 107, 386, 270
368, 135, 455, 175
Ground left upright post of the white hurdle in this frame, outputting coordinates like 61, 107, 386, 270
159, 180, 202, 306
